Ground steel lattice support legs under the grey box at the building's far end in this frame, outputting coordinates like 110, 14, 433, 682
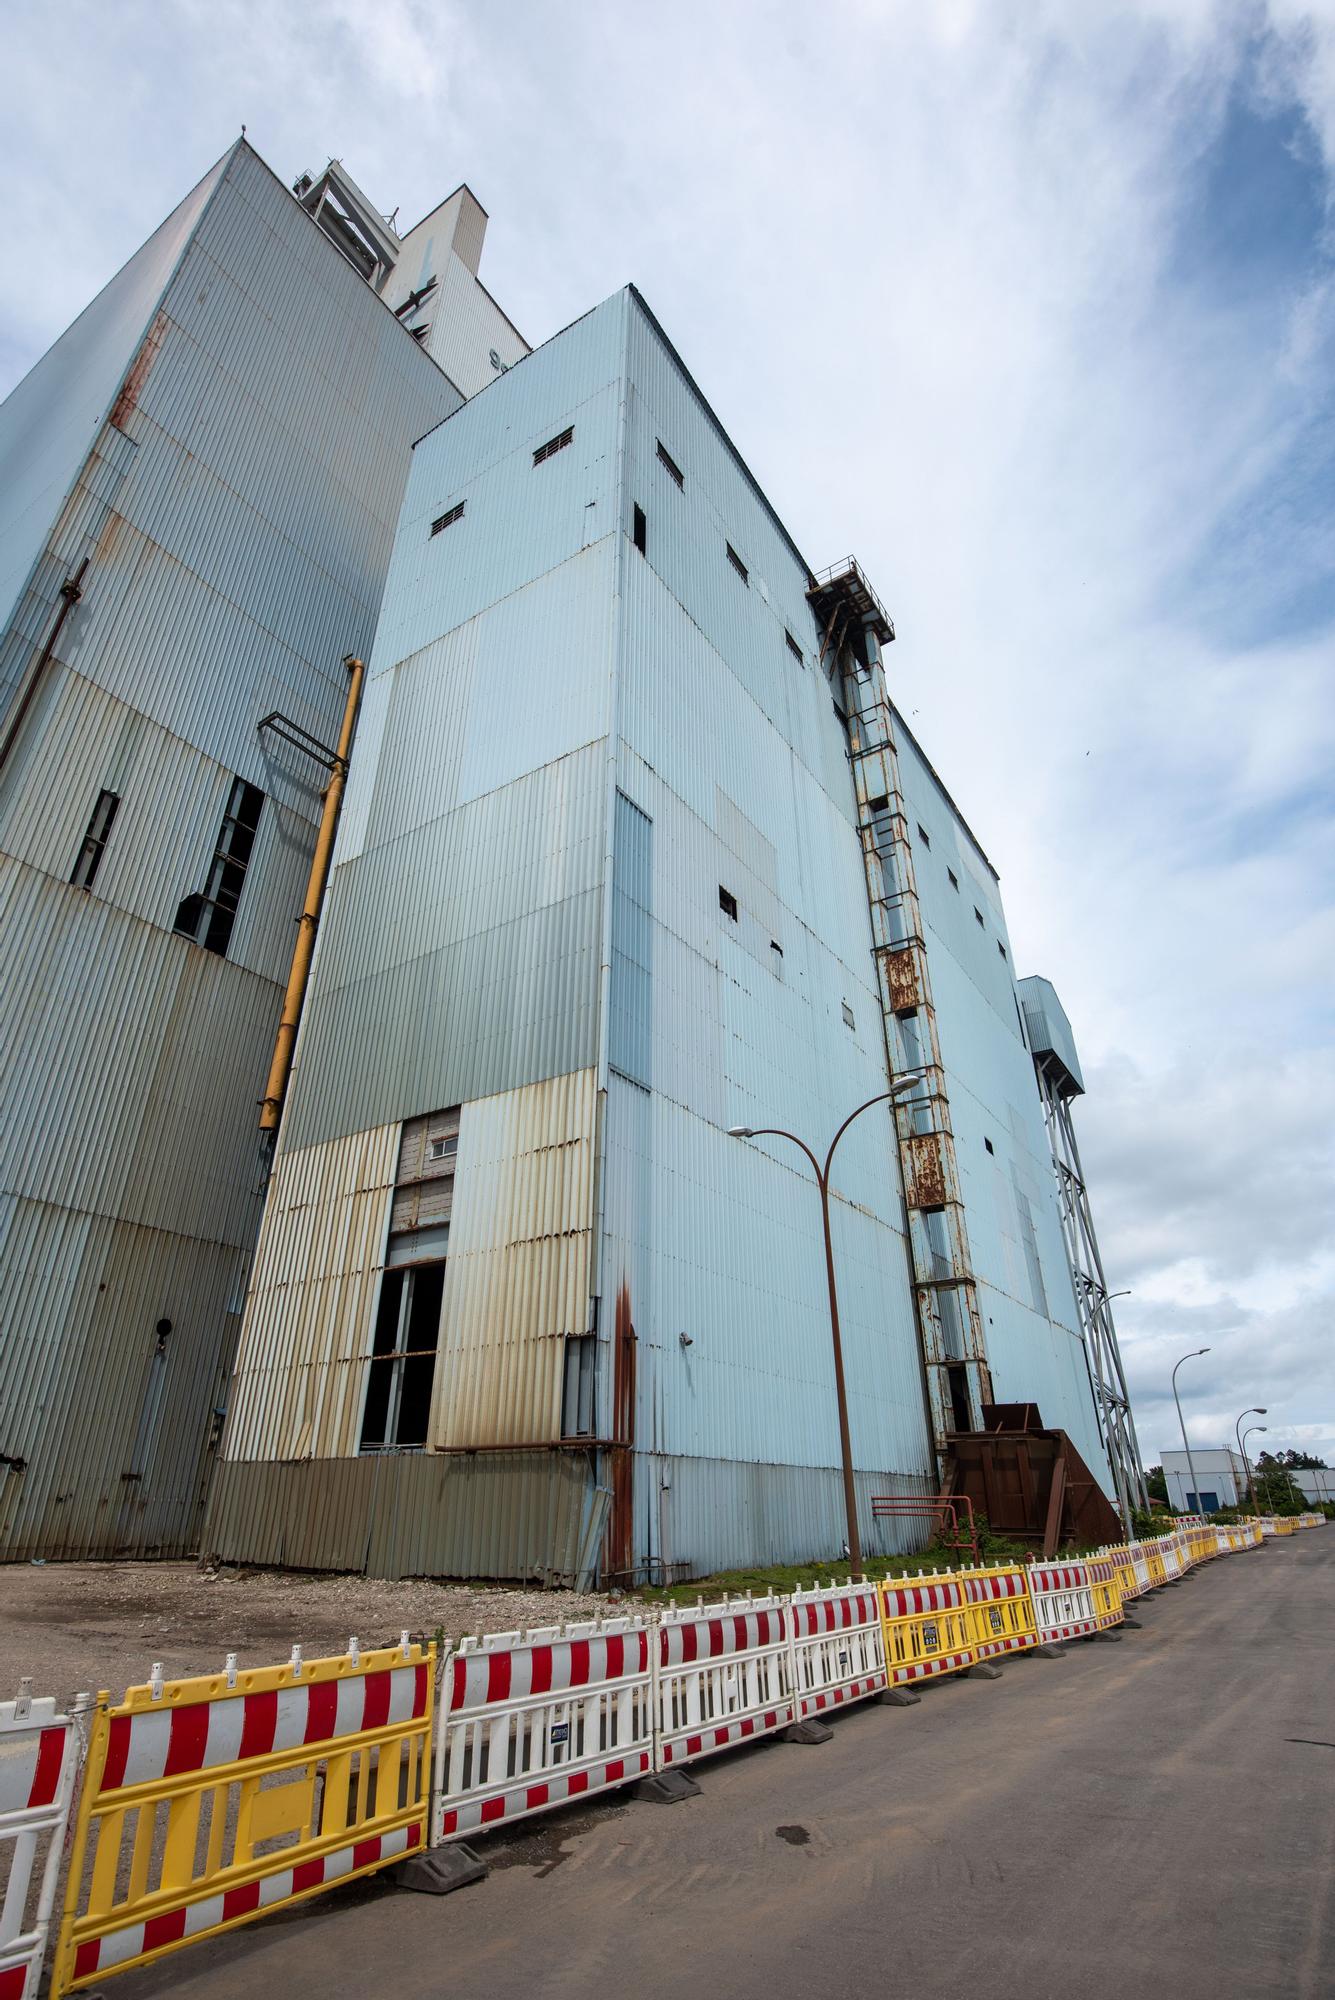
1033, 1054, 1149, 1526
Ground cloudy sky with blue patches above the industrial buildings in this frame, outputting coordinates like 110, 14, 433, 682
0, 0, 1335, 1464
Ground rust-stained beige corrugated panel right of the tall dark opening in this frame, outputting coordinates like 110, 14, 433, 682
432, 1070, 596, 1448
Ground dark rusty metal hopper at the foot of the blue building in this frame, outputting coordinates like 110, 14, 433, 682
943, 1402, 1121, 1556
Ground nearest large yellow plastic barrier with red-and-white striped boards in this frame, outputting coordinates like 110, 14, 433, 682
52, 1634, 436, 1994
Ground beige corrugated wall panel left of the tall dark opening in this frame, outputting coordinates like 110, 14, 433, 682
224, 1124, 400, 1458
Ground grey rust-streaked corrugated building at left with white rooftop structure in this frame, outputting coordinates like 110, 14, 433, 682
0, 142, 528, 1556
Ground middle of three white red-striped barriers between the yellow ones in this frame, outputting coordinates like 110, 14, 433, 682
654, 1598, 793, 1770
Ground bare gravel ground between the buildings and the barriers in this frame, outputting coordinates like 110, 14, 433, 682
0, 1562, 607, 1700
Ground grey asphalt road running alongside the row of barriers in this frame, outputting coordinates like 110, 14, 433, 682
117, 1526, 1335, 2000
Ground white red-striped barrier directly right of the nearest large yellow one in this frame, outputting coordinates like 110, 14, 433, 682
434, 1618, 658, 1844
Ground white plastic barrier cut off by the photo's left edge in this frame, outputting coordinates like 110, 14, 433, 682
0, 1680, 88, 2000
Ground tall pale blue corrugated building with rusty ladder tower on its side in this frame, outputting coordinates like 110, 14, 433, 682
206, 288, 1139, 1580
